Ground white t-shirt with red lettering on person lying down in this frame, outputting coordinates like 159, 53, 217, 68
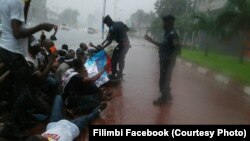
42, 120, 80, 141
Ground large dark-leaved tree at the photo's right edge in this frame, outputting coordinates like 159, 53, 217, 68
216, 0, 250, 63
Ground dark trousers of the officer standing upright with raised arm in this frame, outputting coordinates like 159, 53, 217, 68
159, 58, 176, 99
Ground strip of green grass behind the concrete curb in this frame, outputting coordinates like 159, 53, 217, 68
181, 49, 250, 85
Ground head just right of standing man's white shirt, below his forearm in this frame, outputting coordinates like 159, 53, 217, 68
28, 36, 41, 56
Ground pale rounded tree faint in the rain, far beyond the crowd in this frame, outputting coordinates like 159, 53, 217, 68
59, 8, 80, 27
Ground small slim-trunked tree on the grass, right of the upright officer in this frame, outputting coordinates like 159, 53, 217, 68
193, 13, 218, 56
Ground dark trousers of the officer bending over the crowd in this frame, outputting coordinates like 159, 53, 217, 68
111, 45, 130, 76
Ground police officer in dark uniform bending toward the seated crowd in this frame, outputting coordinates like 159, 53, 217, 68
101, 15, 130, 79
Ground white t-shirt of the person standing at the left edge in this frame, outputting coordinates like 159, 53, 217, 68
0, 0, 28, 56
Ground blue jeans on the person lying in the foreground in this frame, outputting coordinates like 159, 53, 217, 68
50, 95, 100, 130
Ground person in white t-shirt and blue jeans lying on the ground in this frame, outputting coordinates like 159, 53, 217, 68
26, 96, 107, 141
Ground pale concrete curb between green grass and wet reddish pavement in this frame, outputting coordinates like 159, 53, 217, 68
177, 58, 250, 96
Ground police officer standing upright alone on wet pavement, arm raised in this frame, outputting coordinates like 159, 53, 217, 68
145, 15, 180, 105
